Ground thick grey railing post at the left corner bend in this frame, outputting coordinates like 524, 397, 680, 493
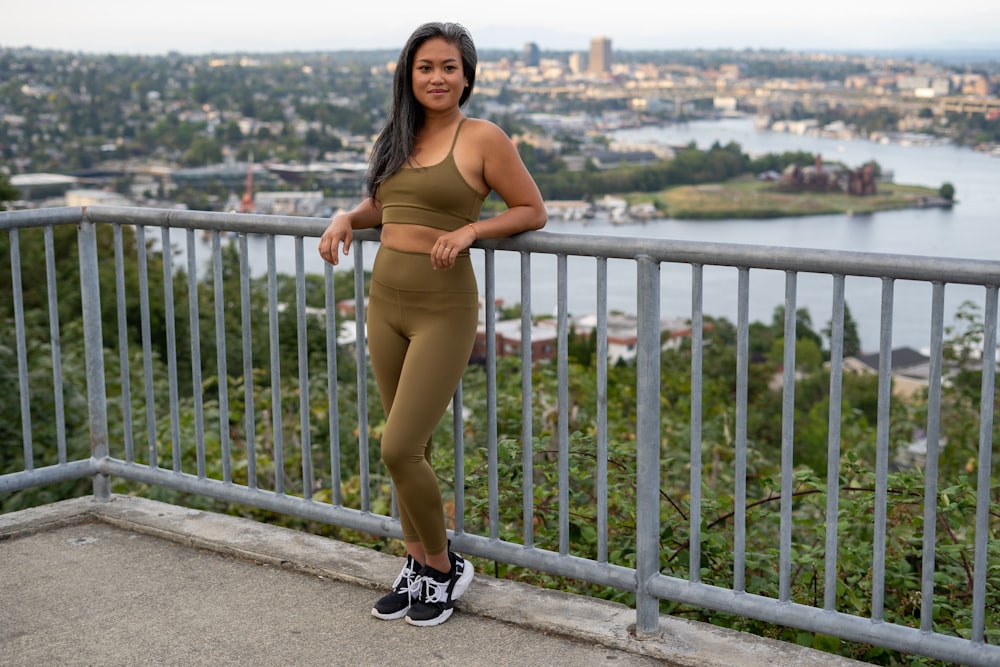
77, 208, 111, 501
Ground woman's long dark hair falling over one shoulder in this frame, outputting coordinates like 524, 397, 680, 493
368, 22, 479, 197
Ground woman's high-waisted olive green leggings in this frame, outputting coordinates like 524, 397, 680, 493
368, 246, 479, 556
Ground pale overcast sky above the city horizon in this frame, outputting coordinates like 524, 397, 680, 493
0, 0, 1000, 54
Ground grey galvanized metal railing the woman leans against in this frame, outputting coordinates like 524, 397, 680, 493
0, 206, 1000, 665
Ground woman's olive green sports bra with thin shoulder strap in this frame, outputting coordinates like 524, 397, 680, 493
378, 118, 485, 232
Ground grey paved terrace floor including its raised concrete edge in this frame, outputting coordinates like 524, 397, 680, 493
0, 496, 860, 667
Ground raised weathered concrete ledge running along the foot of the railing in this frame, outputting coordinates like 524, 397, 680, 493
0, 496, 865, 667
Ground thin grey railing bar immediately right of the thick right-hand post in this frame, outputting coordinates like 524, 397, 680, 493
688, 264, 705, 584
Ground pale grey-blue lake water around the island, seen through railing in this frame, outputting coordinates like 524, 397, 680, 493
227, 118, 1000, 351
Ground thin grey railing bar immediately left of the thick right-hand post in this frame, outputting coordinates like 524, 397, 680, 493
594, 257, 610, 563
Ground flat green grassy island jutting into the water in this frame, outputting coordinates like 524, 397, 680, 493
644, 177, 951, 220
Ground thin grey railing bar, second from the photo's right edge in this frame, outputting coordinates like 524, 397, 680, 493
920, 283, 945, 632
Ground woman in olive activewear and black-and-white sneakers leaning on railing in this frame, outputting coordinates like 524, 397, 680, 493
319, 23, 546, 626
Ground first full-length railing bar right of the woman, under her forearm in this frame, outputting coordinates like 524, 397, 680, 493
482, 250, 500, 540
